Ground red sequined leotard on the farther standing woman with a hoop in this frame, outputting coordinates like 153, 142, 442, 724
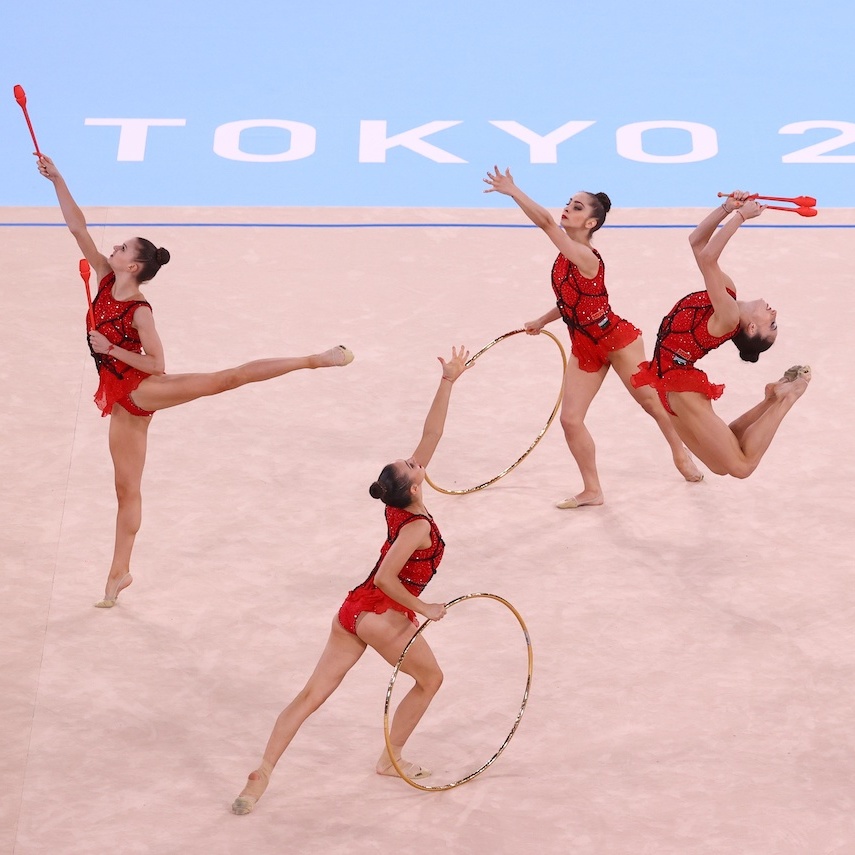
552, 250, 641, 372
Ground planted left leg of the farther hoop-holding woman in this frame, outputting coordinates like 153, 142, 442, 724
557, 353, 609, 508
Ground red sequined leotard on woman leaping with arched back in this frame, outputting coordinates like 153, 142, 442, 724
632, 288, 739, 415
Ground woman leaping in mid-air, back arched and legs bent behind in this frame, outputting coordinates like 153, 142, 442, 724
632, 190, 811, 478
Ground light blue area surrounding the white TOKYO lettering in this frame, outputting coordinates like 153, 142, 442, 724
0, 0, 855, 210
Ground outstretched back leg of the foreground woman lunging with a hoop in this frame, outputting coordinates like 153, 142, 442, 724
232, 616, 366, 814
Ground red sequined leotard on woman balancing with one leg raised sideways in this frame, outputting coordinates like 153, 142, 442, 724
87, 273, 152, 416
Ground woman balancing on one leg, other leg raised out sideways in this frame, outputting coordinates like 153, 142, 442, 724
38, 155, 353, 608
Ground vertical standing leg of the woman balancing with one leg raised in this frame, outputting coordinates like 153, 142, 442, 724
95, 404, 151, 609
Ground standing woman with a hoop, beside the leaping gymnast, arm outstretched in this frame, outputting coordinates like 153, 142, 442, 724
484, 167, 703, 508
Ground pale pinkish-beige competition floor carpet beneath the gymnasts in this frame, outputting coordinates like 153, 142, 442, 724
0, 209, 855, 855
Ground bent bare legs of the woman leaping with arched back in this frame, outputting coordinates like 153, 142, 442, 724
669, 366, 811, 478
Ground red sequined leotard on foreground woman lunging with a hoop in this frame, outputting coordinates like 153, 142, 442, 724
338, 505, 445, 635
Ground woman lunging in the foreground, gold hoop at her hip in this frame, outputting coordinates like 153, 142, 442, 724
232, 346, 469, 814
